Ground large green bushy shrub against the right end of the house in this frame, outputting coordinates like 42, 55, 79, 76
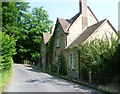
80, 38, 120, 83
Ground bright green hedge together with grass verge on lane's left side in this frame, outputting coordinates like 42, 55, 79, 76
0, 32, 16, 92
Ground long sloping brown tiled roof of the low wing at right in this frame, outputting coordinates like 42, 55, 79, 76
67, 19, 106, 48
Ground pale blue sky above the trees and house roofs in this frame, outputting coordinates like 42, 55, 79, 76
27, 0, 120, 30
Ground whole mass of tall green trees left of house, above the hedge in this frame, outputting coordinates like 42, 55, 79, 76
2, 2, 52, 67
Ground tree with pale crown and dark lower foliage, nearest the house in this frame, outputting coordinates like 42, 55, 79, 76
16, 7, 52, 64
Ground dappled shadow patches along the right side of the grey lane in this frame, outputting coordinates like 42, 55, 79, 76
25, 67, 97, 91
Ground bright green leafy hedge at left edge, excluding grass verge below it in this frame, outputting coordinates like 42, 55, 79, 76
0, 32, 16, 69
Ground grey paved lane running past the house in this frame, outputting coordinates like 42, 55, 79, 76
5, 64, 99, 94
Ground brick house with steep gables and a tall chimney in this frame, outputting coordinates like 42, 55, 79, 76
50, 0, 117, 78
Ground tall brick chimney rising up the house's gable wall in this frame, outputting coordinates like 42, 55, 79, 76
79, 0, 88, 30
